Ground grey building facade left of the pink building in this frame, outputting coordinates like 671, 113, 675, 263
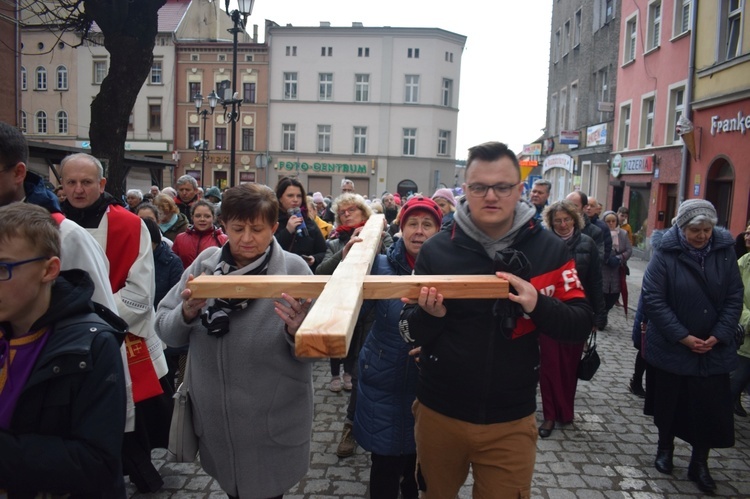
534, 0, 620, 208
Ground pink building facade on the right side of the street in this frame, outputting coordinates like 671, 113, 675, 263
610, 0, 693, 250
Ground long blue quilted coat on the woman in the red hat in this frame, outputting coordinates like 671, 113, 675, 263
354, 239, 418, 456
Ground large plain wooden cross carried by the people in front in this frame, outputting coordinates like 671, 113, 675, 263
188, 215, 508, 358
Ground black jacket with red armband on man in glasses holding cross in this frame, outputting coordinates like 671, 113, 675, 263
402, 220, 593, 424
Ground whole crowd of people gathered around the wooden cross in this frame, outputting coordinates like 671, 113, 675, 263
0, 118, 750, 499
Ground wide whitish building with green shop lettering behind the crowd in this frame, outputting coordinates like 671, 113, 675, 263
266, 23, 466, 197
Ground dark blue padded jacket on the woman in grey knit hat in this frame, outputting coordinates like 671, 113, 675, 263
641, 226, 743, 376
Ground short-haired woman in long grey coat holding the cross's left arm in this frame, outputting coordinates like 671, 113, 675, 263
156, 184, 313, 499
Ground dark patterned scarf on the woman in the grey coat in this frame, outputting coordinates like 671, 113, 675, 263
201, 243, 273, 338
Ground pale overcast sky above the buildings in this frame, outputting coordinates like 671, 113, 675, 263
235, 0, 552, 159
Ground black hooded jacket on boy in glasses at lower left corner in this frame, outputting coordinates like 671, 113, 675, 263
0, 270, 127, 499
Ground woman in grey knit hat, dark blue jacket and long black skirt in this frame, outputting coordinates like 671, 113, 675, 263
641, 199, 743, 494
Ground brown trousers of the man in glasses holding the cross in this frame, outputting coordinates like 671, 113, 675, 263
412, 400, 539, 499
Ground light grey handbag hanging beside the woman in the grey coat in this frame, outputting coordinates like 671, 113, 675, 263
167, 354, 198, 463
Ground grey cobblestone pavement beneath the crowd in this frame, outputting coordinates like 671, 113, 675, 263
128, 261, 750, 499
